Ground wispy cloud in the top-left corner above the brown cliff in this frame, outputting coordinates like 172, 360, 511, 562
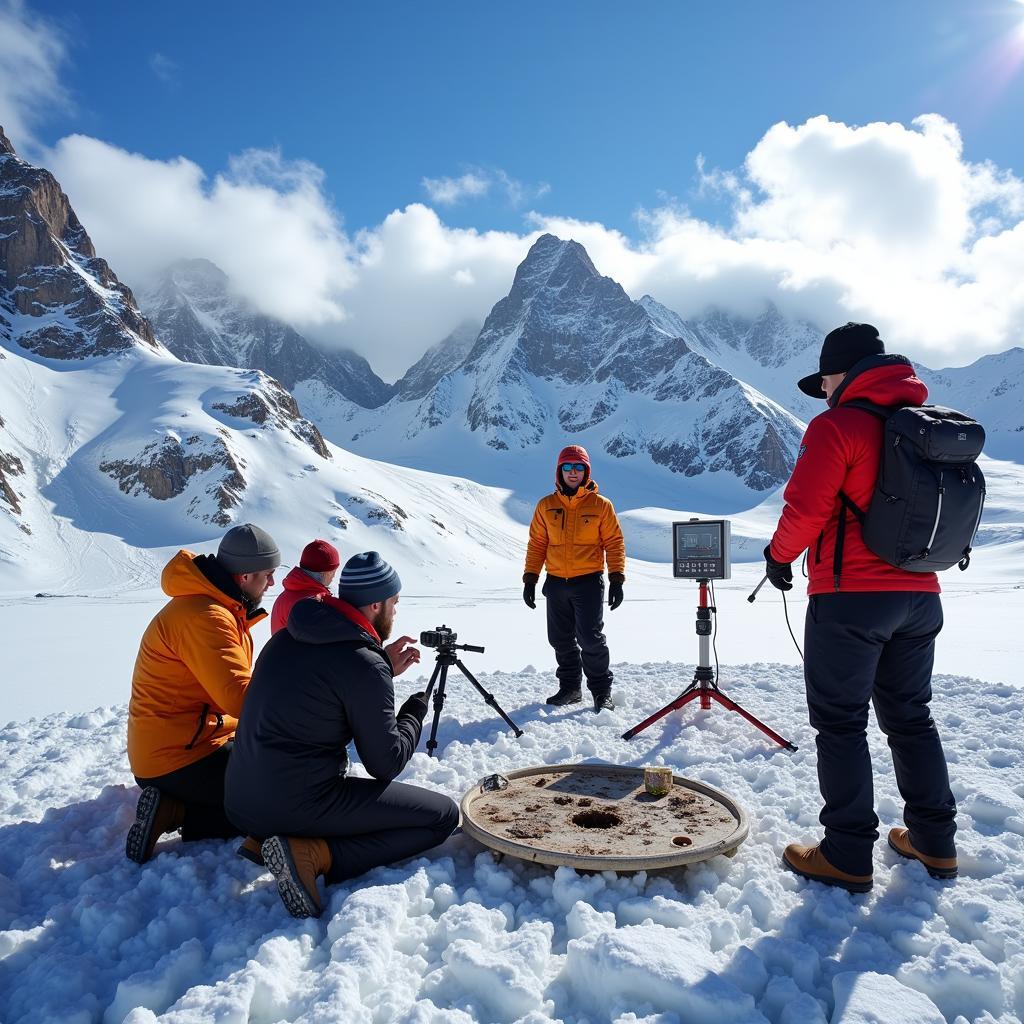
0, 0, 70, 154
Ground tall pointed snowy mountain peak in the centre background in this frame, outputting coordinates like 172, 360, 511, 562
325, 234, 802, 509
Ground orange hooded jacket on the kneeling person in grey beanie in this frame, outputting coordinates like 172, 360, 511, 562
128, 551, 266, 778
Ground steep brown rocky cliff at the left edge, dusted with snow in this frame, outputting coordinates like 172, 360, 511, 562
0, 129, 160, 359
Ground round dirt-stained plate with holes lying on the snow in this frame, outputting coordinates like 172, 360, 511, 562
462, 765, 750, 871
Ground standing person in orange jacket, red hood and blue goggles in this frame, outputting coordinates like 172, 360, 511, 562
522, 444, 626, 712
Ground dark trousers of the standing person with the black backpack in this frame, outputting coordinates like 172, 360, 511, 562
804, 591, 956, 874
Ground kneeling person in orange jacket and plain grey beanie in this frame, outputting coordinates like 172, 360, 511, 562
125, 523, 281, 864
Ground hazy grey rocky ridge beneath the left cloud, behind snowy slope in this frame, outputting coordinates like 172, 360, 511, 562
139, 259, 392, 409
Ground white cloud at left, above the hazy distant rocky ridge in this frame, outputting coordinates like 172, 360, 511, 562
47, 135, 352, 327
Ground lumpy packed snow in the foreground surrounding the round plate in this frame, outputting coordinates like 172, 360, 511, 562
0, 664, 1024, 1024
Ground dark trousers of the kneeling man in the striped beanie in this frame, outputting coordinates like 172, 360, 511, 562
280, 778, 459, 884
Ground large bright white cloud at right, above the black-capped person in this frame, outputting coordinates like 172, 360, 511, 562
532, 115, 1024, 366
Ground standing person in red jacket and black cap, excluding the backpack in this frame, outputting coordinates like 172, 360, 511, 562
765, 324, 956, 892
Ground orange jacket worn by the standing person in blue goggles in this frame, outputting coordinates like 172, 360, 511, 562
525, 480, 626, 580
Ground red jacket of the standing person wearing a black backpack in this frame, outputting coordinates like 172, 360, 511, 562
771, 356, 940, 594
